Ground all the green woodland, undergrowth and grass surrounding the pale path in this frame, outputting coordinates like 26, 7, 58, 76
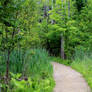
0, 0, 92, 92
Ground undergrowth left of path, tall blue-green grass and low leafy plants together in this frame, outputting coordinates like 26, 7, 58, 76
0, 49, 55, 92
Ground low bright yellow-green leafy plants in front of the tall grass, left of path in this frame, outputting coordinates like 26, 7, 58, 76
5, 74, 54, 92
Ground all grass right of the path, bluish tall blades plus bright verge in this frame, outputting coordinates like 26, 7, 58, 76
71, 50, 92, 89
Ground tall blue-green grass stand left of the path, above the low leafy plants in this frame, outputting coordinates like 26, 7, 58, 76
0, 49, 52, 75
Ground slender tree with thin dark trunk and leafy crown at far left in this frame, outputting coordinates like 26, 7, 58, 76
0, 0, 35, 83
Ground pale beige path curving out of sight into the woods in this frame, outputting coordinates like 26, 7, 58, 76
52, 62, 90, 92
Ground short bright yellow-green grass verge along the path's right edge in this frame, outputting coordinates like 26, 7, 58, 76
71, 58, 92, 89
